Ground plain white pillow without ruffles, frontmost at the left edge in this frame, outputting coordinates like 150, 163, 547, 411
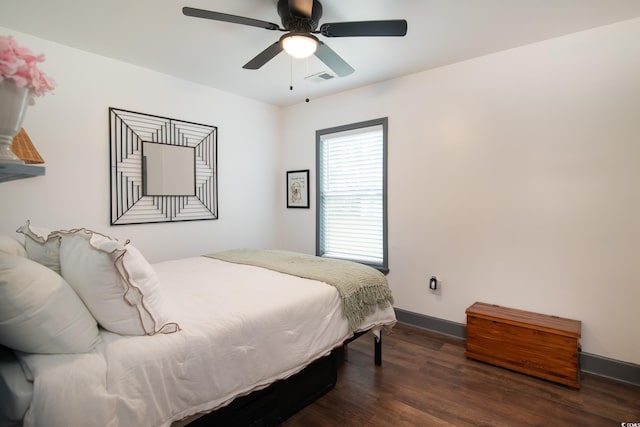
0, 255, 98, 353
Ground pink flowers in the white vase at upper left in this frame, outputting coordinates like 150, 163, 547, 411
0, 36, 56, 104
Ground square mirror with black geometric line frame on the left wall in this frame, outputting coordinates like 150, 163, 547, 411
109, 107, 218, 225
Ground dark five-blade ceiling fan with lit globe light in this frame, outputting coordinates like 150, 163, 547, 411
182, 0, 407, 77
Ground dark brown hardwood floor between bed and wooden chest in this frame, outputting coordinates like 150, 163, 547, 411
282, 324, 640, 427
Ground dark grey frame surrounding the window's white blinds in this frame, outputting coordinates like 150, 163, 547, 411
315, 117, 389, 274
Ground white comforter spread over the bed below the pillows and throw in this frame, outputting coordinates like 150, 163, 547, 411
20, 257, 395, 427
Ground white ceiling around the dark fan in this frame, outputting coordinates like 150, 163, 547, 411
0, 0, 640, 106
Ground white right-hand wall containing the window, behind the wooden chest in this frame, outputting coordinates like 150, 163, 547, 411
280, 19, 640, 363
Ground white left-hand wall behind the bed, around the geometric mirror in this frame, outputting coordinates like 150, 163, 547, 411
0, 28, 282, 262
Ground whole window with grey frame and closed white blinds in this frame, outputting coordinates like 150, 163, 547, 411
316, 117, 388, 272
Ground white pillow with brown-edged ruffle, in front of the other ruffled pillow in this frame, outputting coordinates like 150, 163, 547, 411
59, 229, 180, 335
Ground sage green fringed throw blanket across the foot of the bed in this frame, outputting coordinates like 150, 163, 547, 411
205, 249, 393, 332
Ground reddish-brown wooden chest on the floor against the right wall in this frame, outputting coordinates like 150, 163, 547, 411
465, 302, 581, 388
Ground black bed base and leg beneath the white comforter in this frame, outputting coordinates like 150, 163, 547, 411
188, 331, 382, 427
